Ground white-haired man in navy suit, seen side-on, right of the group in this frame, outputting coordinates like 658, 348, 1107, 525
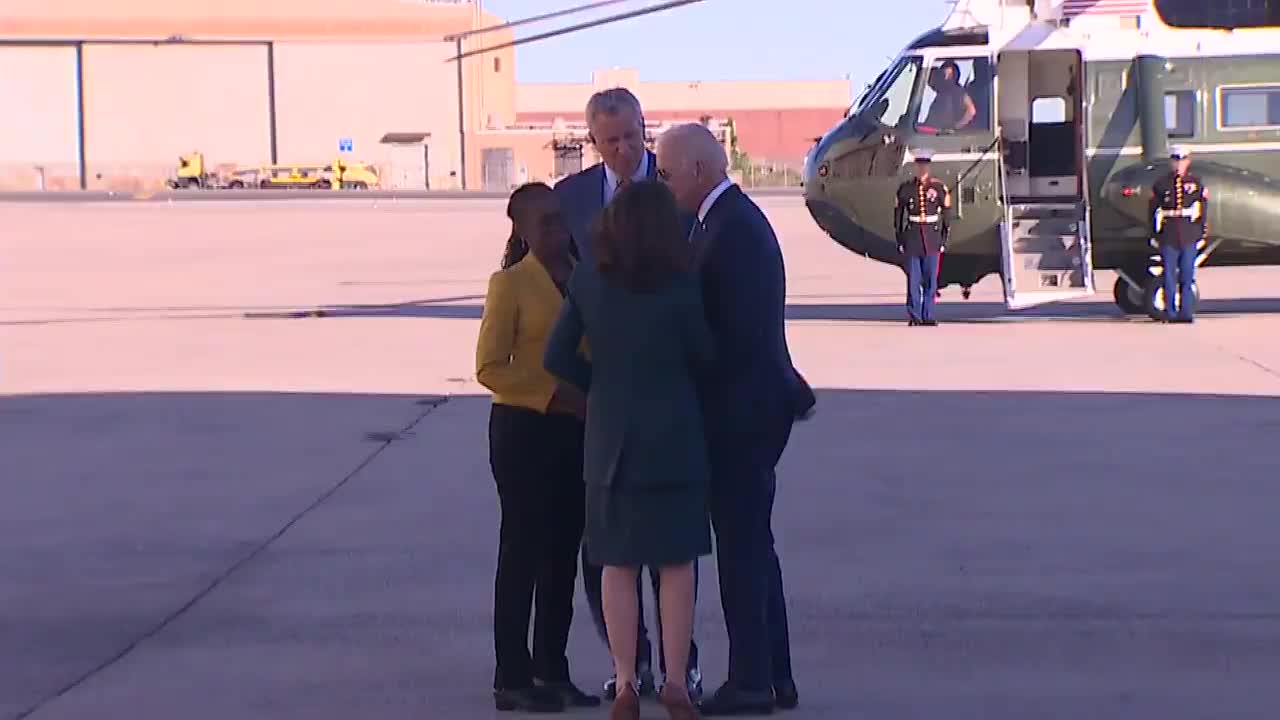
658, 124, 798, 715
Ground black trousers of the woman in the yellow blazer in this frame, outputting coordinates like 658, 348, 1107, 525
489, 404, 586, 689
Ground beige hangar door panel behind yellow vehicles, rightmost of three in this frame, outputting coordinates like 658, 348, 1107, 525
275, 42, 460, 188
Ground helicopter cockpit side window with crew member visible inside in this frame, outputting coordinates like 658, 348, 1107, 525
915, 58, 991, 135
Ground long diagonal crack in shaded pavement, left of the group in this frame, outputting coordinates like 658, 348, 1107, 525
13, 396, 449, 720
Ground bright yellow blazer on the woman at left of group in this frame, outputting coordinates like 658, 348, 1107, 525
476, 252, 586, 413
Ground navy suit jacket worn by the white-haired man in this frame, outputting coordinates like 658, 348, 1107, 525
699, 186, 798, 468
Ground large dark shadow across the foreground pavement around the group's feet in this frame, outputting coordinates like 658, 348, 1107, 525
0, 389, 1280, 720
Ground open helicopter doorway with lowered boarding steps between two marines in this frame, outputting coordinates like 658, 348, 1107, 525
997, 50, 1094, 310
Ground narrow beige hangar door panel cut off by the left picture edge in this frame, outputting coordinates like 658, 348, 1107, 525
0, 46, 79, 190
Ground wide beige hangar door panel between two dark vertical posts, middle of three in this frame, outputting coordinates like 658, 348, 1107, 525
83, 44, 271, 190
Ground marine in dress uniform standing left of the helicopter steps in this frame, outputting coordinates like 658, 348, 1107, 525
893, 149, 951, 325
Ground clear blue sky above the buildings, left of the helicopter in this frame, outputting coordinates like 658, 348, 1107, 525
483, 0, 951, 94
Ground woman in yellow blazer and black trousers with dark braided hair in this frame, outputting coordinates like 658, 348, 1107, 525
476, 183, 600, 712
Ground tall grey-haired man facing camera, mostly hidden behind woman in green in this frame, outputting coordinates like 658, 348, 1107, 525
556, 87, 703, 700
